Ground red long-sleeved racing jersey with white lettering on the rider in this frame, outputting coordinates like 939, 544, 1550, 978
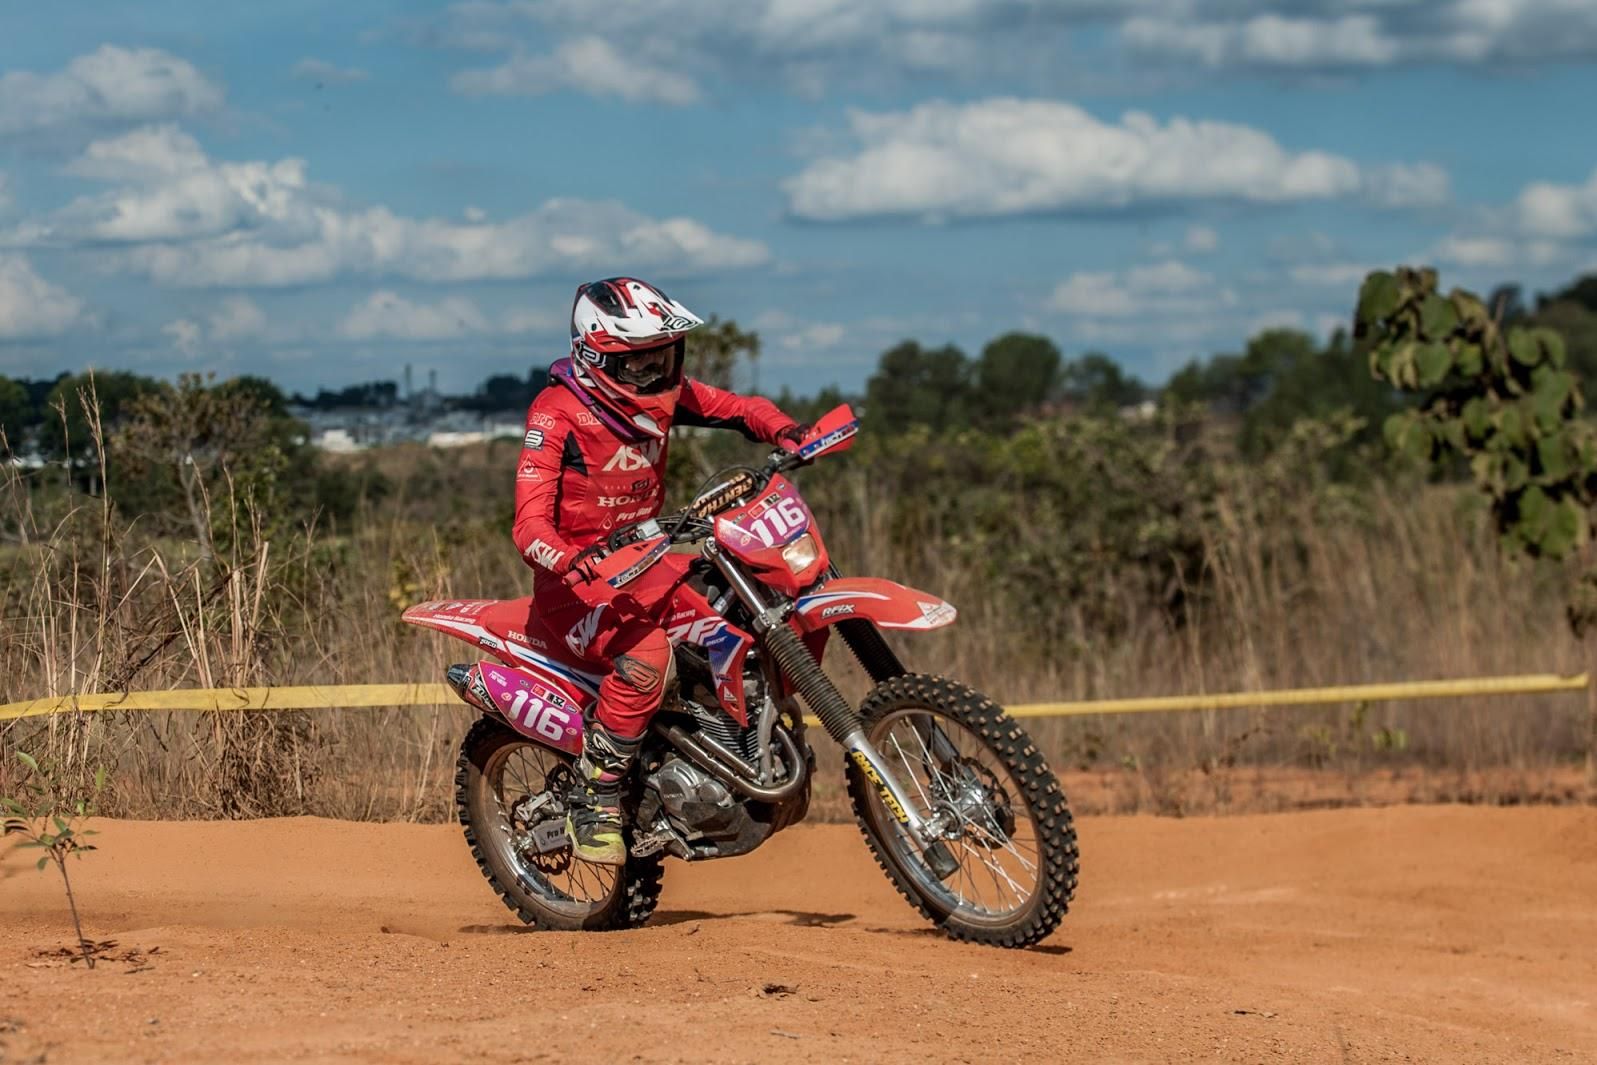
511, 380, 794, 575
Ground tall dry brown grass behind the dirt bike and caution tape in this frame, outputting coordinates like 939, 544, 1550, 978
0, 428, 1583, 819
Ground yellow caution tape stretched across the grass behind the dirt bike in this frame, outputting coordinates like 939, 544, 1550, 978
0, 674, 1587, 725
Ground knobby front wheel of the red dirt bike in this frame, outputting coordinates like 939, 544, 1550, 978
845, 674, 1078, 947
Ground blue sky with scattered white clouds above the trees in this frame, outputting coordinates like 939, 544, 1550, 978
0, 0, 1597, 393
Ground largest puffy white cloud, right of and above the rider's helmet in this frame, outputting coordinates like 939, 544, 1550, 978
786, 99, 1436, 220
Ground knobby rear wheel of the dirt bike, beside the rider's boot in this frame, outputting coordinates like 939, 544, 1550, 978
455, 717, 663, 931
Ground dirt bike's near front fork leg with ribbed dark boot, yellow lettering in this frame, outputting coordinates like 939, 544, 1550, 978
704, 540, 958, 878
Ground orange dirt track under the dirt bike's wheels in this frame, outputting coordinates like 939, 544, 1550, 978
0, 806, 1597, 1065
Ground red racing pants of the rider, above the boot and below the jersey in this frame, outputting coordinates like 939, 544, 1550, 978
532, 554, 693, 739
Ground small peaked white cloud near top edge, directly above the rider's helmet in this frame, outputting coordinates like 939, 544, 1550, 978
450, 37, 699, 107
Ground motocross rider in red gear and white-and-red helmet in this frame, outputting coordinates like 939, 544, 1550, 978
513, 278, 805, 865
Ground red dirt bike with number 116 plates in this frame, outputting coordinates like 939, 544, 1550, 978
404, 406, 1078, 947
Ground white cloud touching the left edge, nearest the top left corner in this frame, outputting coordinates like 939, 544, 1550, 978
0, 45, 222, 134
